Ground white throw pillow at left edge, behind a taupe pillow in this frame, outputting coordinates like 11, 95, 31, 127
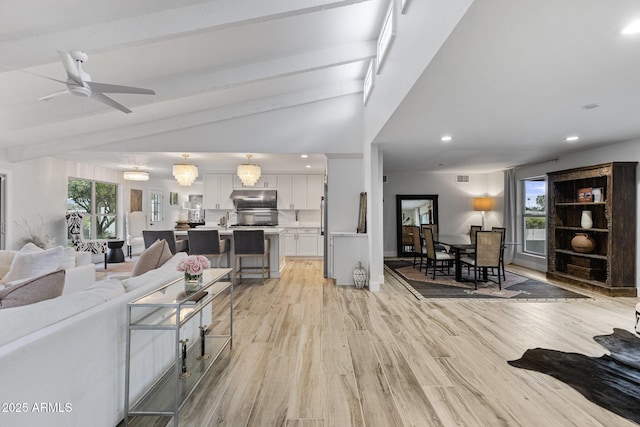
2, 245, 64, 283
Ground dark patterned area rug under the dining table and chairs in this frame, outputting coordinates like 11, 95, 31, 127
384, 258, 589, 300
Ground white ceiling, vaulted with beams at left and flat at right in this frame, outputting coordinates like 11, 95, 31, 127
0, 0, 640, 174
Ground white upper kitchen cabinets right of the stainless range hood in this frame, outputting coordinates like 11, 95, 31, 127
278, 175, 324, 210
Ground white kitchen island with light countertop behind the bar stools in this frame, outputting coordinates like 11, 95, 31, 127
175, 226, 285, 279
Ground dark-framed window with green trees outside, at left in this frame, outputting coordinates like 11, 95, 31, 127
67, 178, 118, 240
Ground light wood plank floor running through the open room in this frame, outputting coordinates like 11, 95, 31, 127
126, 260, 640, 427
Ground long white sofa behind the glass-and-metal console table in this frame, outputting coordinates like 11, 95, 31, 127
0, 253, 211, 427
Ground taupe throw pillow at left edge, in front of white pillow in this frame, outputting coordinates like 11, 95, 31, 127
0, 270, 65, 308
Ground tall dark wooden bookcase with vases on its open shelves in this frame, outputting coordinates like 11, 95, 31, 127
547, 162, 637, 296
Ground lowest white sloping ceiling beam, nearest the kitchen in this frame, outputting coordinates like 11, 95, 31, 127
7, 80, 363, 162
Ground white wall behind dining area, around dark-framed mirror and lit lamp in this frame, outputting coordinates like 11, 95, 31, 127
383, 172, 504, 256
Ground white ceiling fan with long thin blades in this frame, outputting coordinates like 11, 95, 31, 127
14, 50, 156, 114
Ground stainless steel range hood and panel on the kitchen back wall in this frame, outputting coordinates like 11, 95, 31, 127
231, 190, 278, 226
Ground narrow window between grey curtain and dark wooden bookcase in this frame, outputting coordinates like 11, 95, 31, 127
523, 177, 547, 255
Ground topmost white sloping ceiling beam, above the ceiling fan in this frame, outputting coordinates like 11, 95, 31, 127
0, 0, 372, 68
